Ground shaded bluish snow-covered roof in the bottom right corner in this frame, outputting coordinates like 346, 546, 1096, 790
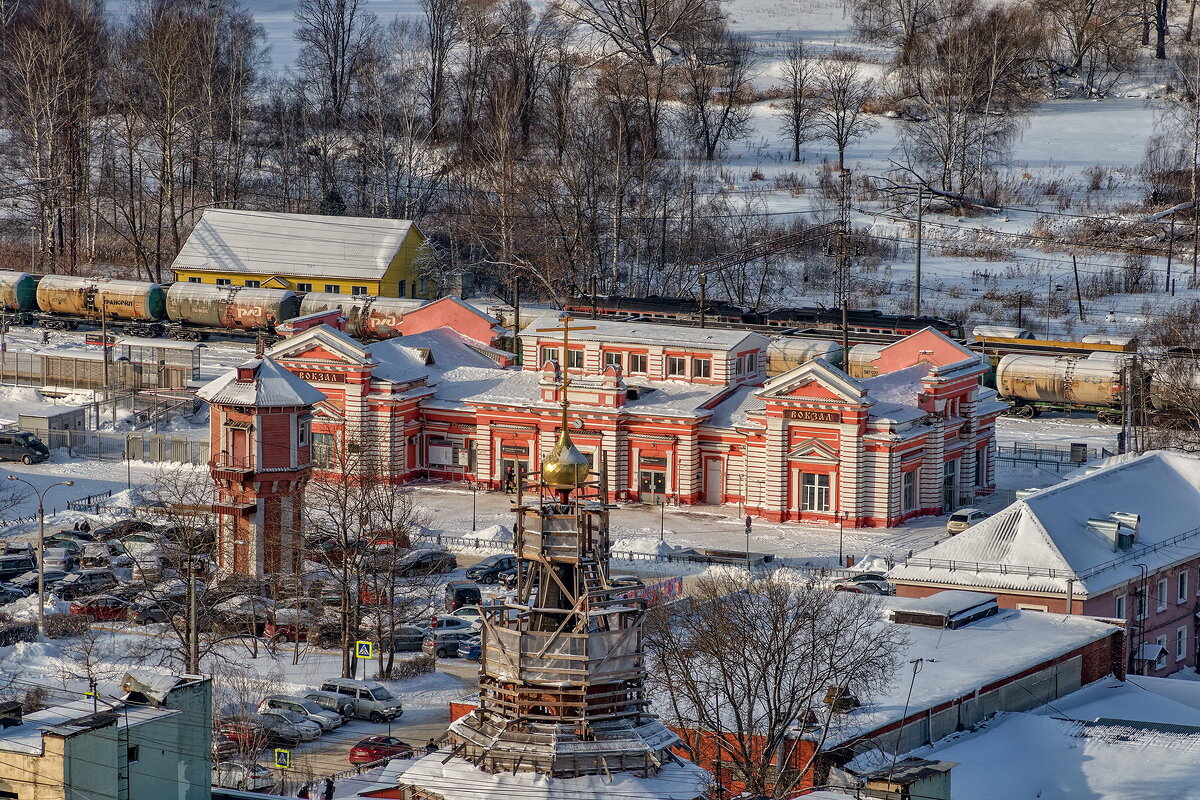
878, 675, 1200, 800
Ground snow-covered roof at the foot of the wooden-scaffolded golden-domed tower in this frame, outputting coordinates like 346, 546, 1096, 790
392, 751, 713, 800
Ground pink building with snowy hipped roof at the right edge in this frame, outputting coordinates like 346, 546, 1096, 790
889, 452, 1200, 675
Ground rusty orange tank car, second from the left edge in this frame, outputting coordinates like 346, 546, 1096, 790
37, 275, 167, 336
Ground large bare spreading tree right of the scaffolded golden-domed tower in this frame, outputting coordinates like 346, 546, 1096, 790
647, 572, 904, 798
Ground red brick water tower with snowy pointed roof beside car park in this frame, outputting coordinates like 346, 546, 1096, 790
197, 359, 325, 581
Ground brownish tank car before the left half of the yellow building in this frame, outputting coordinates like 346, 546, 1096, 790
167, 283, 300, 341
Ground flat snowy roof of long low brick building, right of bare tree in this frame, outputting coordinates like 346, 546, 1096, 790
826, 593, 1118, 748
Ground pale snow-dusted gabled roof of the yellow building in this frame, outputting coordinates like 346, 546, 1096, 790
172, 209, 414, 281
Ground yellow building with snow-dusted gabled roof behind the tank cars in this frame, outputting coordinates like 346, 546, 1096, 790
172, 209, 432, 297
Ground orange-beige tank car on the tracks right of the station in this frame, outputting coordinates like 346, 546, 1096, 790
996, 353, 1138, 422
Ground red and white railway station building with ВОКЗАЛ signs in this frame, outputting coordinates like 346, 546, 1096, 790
216, 317, 1004, 527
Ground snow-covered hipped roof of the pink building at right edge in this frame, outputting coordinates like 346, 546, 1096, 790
888, 452, 1200, 596
